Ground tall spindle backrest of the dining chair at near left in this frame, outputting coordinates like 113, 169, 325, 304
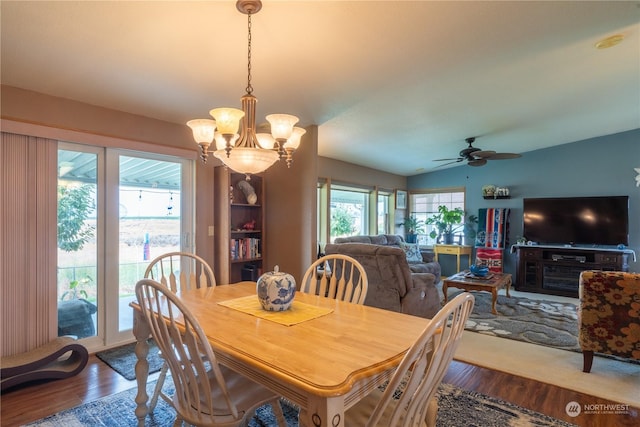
136, 279, 242, 425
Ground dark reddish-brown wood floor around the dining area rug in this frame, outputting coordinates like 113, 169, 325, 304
0, 355, 640, 427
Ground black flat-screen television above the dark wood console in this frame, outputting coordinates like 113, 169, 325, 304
523, 196, 629, 246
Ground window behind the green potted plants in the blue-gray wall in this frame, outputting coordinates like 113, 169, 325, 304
409, 187, 465, 246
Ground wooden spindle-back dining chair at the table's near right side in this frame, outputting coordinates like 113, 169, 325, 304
345, 292, 475, 427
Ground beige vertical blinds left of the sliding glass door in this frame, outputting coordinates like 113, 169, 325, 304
0, 132, 57, 356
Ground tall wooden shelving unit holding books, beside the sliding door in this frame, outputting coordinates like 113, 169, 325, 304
213, 166, 265, 284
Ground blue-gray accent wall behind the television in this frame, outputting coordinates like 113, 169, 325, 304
407, 129, 640, 274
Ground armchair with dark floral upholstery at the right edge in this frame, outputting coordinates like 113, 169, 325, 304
578, 271, 640, 372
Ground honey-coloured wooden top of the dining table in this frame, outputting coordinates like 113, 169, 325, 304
146, 282, 429, 396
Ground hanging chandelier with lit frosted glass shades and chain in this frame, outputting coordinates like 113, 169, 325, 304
187, 0, 306, 179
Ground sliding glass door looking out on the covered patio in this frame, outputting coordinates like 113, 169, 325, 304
58, 143, 194, 346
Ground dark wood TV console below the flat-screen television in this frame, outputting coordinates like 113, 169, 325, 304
511, 245, 635, 298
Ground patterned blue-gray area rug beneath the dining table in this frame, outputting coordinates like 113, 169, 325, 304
27, 381, 573, 427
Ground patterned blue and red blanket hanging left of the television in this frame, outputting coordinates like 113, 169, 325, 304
475, 208, 511, 273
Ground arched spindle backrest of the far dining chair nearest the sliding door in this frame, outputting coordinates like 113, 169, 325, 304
144, 252, 216, 292
